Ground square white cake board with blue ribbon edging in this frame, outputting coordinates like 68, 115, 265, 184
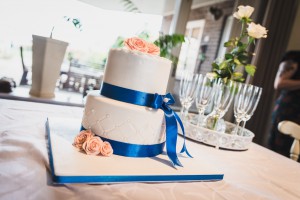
46, 118, 224, 184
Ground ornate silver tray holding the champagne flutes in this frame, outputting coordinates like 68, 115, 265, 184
181, 115, 255, 150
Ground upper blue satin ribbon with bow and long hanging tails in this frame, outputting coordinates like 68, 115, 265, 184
100, 82, 192, 166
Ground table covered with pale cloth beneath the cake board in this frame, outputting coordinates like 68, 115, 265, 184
0, 99, 300, 200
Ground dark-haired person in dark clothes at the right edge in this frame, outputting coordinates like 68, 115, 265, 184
269, 51, 300, 157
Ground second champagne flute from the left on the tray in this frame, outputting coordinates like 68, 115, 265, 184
196, 74, 215, 126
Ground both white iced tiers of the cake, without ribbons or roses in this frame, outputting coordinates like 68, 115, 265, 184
82, 48, 171, 150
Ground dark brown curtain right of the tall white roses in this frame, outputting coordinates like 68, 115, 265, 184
246, 0, 299, 146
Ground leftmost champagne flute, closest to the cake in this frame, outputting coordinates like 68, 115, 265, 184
179, 71, 199, 121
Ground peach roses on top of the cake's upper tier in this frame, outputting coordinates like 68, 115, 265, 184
124, 37, 160, 55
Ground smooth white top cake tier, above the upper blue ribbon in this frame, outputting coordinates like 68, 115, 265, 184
103, 49, 171, 94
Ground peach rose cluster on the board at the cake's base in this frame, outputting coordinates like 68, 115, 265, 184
73, 130, 113, 156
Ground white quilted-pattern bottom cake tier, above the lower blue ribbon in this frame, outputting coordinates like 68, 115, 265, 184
82, 90, 165, 144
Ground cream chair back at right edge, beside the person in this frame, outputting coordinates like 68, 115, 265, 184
278, 120, 300, 161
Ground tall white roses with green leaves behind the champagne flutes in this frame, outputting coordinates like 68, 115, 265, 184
208, 5, 267, 82
